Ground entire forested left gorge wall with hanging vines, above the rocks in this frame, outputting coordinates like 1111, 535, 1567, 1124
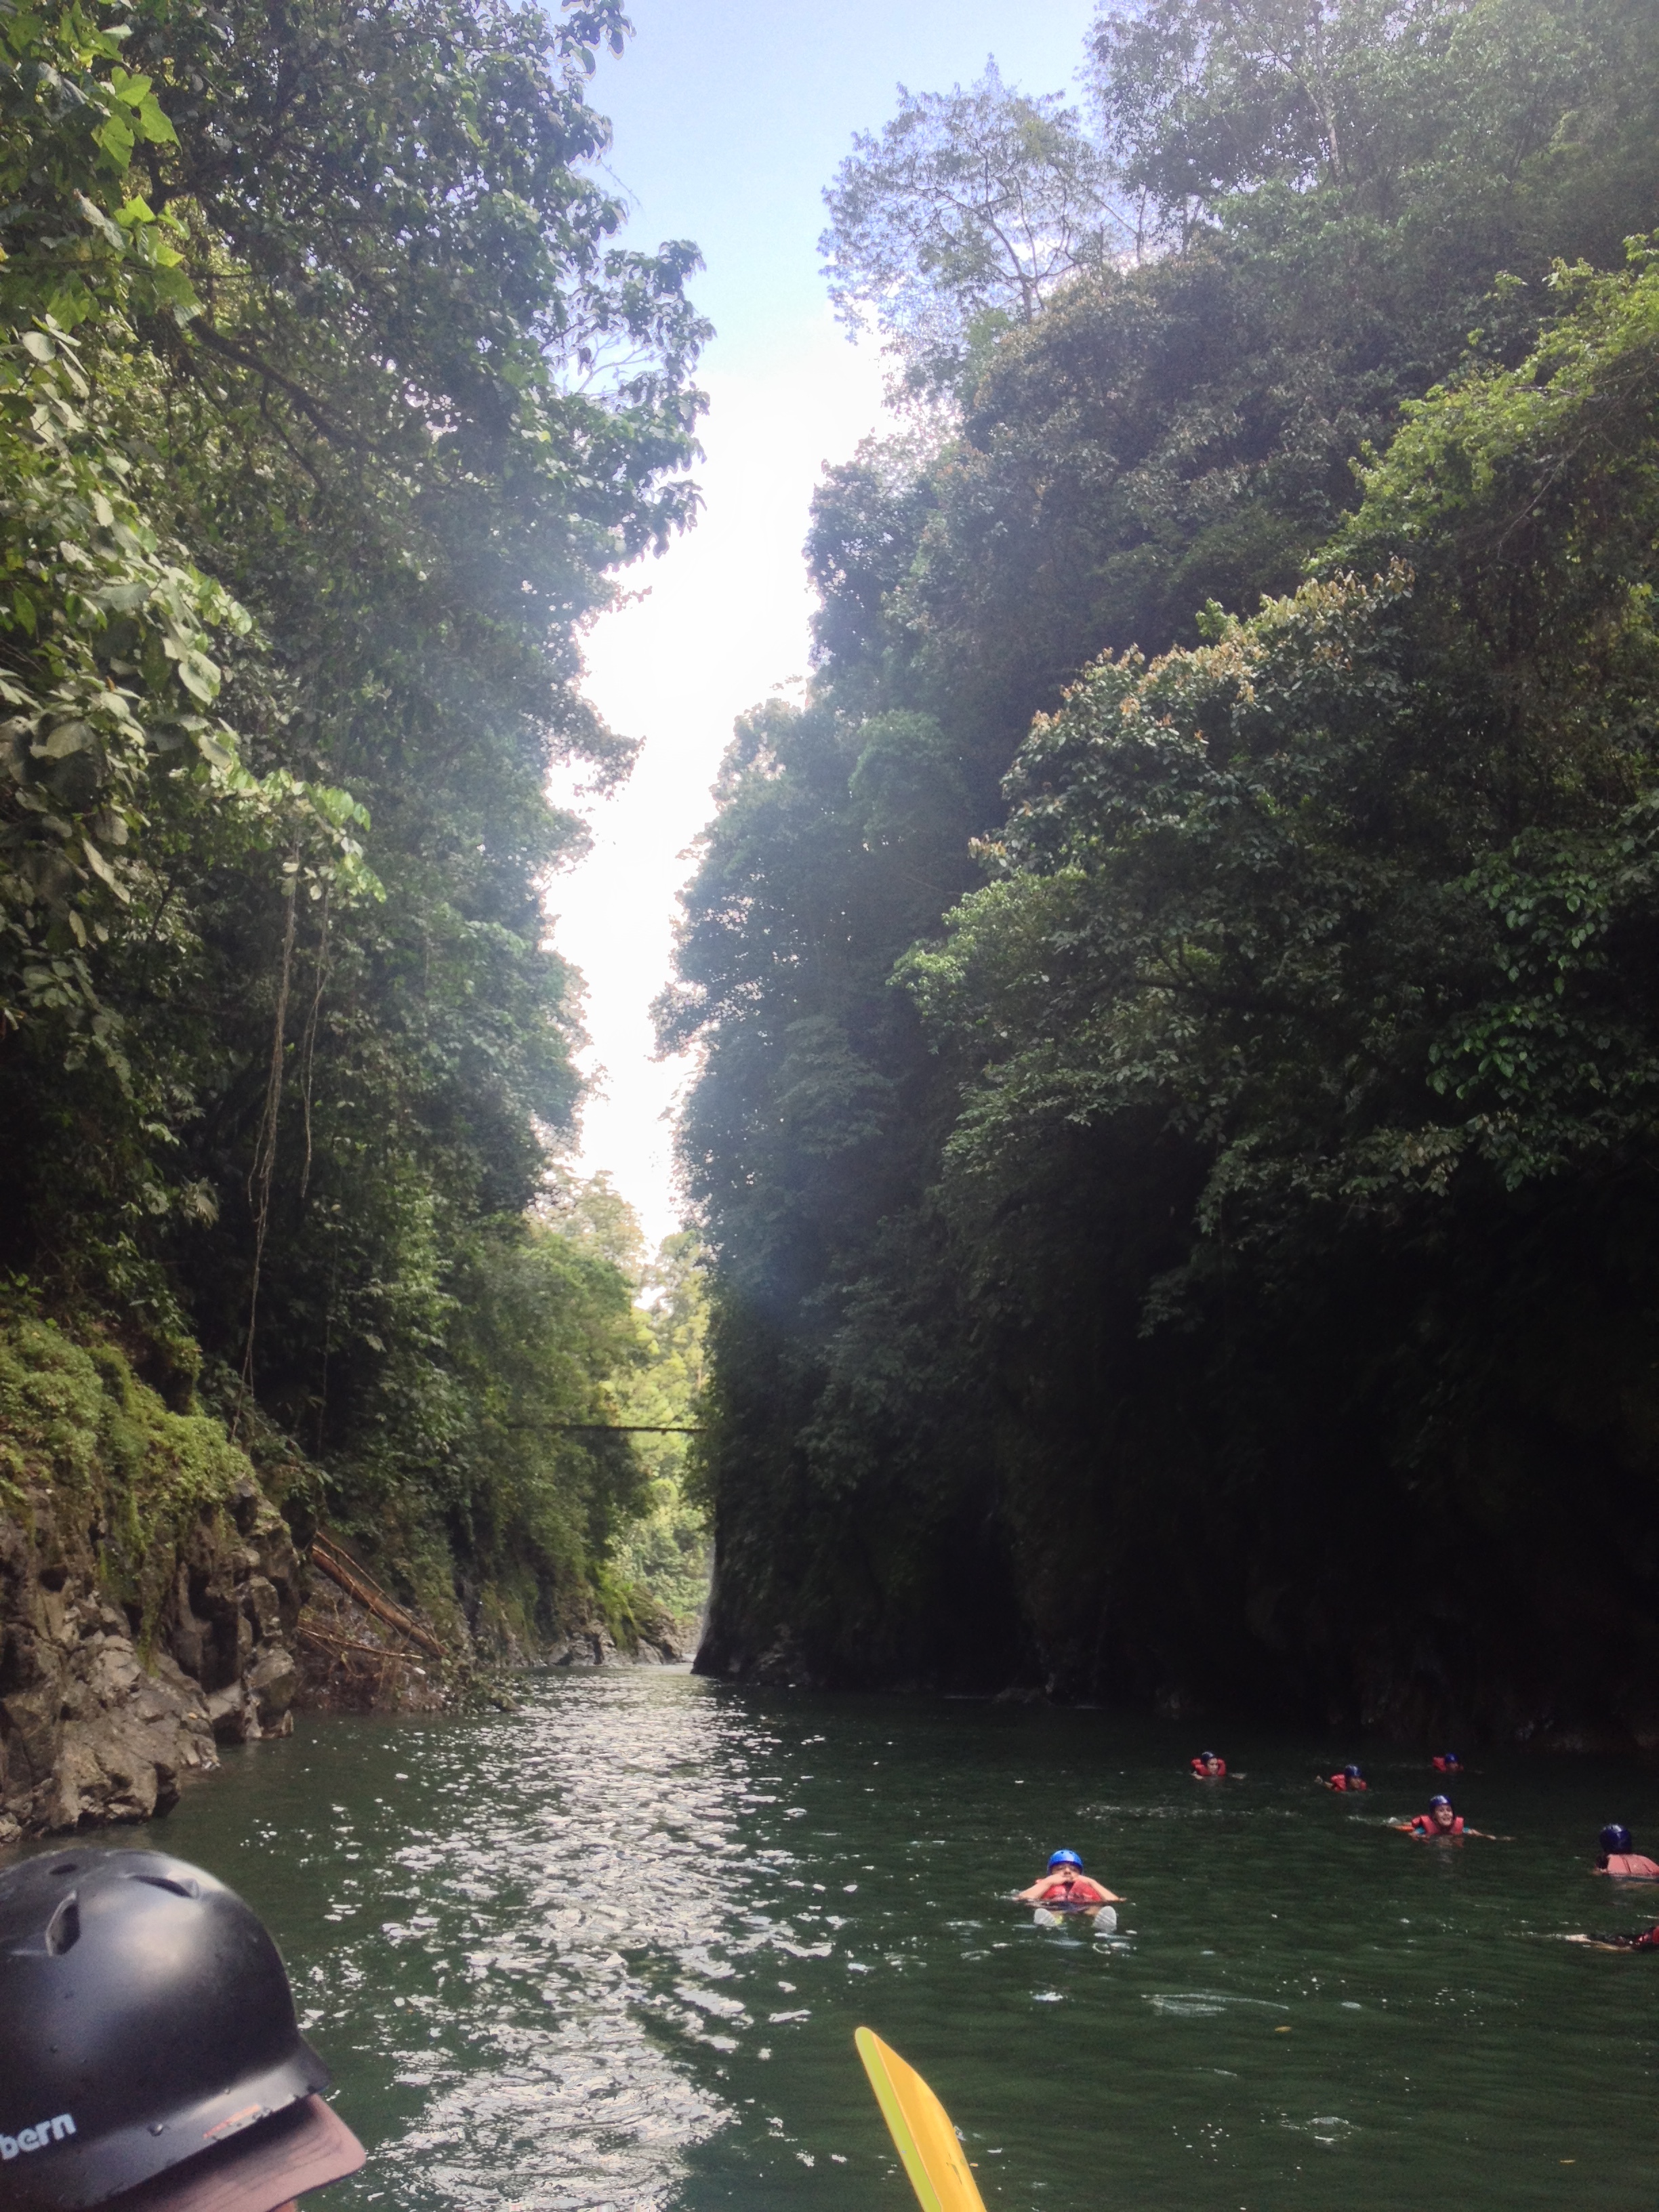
0, 0, 705, 1633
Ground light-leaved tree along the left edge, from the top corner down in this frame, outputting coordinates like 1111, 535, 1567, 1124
0, 7, 374, 1061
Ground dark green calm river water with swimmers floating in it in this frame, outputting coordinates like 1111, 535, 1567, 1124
58, 1670, 1659, 2212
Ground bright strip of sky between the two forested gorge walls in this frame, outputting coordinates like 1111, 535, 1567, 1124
548, 0, 1092, 1243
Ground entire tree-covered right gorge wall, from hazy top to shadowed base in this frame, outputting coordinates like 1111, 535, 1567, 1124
663, 0, 1659, 1732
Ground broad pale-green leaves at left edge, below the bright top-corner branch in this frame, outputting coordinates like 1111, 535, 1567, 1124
0, 323, 378, 1073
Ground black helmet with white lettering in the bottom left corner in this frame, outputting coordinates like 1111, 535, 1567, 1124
0, 1849, 361, 2212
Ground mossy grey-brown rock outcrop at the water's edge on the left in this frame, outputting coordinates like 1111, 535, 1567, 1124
0, 1318, 305, 1843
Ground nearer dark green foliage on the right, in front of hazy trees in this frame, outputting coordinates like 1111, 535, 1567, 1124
889, 254, 1659, 1725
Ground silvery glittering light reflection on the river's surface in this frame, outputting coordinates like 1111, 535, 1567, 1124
312, 1677, 765, 2212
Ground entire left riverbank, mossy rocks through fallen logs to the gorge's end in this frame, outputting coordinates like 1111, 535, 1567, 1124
0, 1314, 679, 1845
